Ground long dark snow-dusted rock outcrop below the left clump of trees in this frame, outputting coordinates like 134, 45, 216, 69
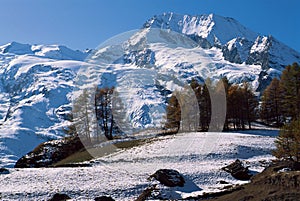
15, 137, 84, 168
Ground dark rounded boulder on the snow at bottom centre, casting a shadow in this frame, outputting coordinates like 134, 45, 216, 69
149, 169, 185, 187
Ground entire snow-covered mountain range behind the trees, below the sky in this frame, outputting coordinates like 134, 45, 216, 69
0, 13, 300, 166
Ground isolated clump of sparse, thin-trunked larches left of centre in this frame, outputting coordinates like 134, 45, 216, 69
72, 87, 120, 143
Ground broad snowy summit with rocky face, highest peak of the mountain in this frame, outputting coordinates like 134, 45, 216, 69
144, 12, 259, 46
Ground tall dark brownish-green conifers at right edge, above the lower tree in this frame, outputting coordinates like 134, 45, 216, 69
260, 63, 300, 126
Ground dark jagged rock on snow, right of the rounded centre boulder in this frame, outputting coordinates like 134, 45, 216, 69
222, 159, 253, 180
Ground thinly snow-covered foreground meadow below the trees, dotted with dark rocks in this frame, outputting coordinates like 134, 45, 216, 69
0, 128, 278, 200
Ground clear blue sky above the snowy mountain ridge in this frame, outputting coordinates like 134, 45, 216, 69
0, 0, 300, 52
